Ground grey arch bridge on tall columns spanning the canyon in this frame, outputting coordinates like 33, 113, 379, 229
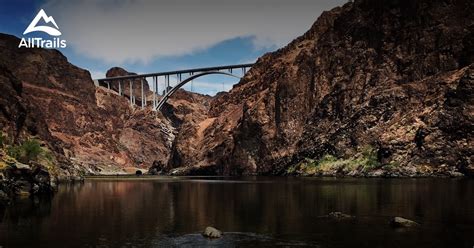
95, 64, 253, 111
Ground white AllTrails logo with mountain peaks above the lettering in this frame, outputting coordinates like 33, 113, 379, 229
18, 9, 66, 48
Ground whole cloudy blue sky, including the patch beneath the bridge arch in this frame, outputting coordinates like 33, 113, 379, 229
0, 0, 347, 95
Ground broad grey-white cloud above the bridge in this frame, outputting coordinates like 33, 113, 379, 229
43, 0, 346, 64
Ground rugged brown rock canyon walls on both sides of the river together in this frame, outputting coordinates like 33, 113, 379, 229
0, 0, 474, 176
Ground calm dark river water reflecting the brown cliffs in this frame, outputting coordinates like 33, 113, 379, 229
0, 177, 474, 248
